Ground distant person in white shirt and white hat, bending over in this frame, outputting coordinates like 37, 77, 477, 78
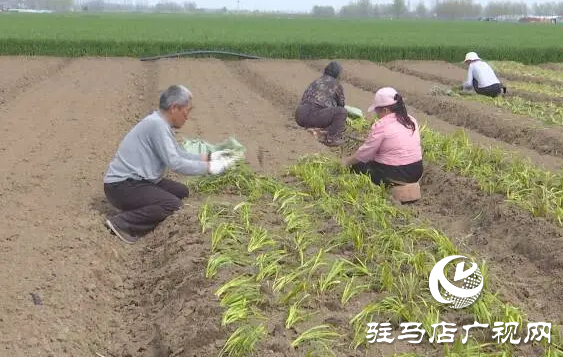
463, 52, 506, 98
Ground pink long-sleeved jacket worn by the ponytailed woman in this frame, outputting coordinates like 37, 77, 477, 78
355, 113, 422, 166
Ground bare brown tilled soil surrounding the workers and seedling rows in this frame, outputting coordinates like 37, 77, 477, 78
0, 57, 563, 357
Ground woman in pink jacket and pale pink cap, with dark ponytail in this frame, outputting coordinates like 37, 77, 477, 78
343, 87, 423, 185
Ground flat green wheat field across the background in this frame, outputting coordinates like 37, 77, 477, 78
0, 13, 563, 64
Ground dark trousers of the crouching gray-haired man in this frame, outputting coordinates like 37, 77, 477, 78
104, 179, 189, 236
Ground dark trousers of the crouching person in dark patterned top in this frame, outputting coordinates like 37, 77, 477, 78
295, 103, 348, 140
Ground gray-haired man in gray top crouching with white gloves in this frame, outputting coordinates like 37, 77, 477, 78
104, 85, 236, 243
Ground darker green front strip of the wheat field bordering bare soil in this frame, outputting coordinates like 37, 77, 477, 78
0, 35, 563, 62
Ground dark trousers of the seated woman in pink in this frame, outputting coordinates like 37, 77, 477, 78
351, 161, 423, 186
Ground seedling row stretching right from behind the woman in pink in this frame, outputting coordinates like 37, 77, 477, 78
350, 114, 563, 226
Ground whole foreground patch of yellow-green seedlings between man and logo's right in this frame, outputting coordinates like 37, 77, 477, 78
188, 156, 557, 356
